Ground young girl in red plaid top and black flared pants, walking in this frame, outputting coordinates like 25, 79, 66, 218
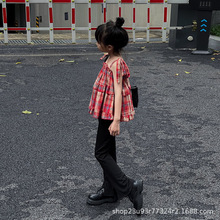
87, 17, 143, 210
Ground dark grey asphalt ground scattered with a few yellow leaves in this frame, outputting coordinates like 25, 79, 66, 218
0, 43, 220, 220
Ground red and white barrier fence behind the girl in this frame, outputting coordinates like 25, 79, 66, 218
0, 0, 174, 44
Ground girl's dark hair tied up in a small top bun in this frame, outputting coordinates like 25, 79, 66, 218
95, 17, 129, 54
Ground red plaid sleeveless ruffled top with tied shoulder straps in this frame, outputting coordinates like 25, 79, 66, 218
89, 55, 135, 121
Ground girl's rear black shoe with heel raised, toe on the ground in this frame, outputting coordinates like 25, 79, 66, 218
128, 180, 143, 211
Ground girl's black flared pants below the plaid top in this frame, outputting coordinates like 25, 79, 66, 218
95, 119, 133, 198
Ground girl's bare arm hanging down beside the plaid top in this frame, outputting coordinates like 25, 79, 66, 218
109, 62, 122, 136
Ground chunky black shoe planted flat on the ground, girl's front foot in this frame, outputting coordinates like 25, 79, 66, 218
87, 188, 117, 205
